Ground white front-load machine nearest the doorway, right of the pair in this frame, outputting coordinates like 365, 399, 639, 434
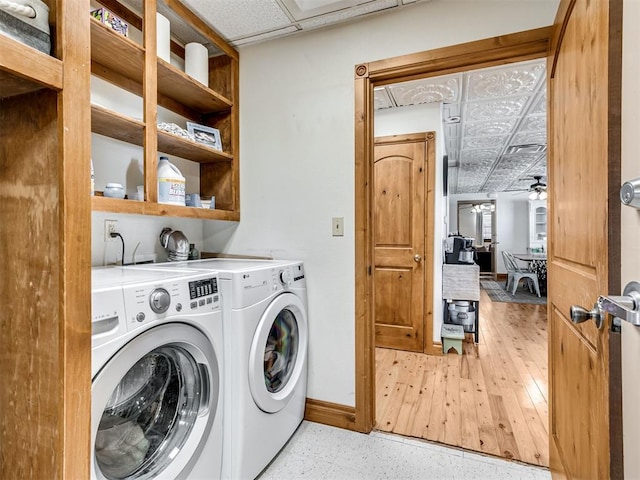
127, 259, 308, 480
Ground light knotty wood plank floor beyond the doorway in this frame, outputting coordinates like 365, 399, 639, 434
376, 291, 549, 466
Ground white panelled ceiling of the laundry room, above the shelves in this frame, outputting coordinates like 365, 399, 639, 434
183, 0, 429, 46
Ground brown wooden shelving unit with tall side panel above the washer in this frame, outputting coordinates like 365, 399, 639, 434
0, 0, 240, 474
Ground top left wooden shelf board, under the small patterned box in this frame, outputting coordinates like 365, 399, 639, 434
89, 17, 144, 84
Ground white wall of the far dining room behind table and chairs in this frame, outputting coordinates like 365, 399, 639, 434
449, 192, 529, 273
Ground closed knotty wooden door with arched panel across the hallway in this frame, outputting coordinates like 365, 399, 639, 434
372, 134, 433, 352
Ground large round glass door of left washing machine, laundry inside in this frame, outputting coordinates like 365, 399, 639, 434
92, 327, 219, 480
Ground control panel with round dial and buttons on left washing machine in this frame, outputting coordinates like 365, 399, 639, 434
123, 273, 221, 330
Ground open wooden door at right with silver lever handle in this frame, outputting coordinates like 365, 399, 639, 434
548, 0, 621, 479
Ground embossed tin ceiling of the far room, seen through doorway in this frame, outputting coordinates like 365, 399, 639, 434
375, 59, 547, 193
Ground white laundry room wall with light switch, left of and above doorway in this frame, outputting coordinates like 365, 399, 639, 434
204, 0, 558, 405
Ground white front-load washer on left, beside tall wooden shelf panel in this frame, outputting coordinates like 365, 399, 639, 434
91, 267, 224, 480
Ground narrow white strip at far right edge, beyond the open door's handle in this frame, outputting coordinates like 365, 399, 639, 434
614, 0, 640, 479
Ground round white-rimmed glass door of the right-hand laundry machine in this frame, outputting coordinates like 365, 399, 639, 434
248, 293, 307, 413
